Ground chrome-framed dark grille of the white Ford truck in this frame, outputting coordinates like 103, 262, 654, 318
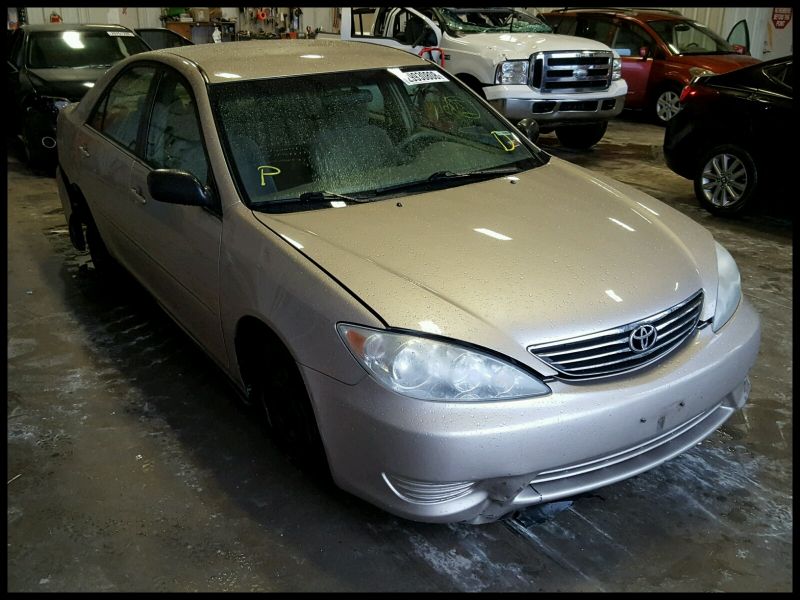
529, 50, 614, 92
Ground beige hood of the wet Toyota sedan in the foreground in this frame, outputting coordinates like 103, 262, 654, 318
254, 158, 717, 363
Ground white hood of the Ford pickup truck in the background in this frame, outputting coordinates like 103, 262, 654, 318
453, 33, 611, 61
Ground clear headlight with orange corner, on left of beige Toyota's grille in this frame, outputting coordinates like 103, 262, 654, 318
337, 323, 550, 402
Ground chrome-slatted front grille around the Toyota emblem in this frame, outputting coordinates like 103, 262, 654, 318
528, 290, 703, 379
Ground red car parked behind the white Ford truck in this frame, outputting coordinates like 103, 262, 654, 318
543, 8, 759, 124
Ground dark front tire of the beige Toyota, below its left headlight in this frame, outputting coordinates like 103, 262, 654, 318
247, 345, 329, 475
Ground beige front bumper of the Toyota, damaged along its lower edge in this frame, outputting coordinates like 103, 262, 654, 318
303, 299, 760, 523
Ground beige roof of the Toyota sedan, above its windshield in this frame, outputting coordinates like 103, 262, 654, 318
157, 39, 431, 83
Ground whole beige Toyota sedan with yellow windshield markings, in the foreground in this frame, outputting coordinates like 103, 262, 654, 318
57, 40, 760, 523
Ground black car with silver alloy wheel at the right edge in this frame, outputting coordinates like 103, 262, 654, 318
664, 56, 795, 216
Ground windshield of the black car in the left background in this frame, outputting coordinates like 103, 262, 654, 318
28, 30, 150, 69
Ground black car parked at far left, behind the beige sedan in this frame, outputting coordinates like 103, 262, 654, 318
7, 23, 150, 166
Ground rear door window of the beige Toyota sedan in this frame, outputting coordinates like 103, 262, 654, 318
89, 67, 155, 152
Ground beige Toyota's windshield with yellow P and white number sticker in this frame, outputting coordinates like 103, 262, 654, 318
209, 65, 546, 211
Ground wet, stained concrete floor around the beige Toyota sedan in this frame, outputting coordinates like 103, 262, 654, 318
7, 118, 792, 592
